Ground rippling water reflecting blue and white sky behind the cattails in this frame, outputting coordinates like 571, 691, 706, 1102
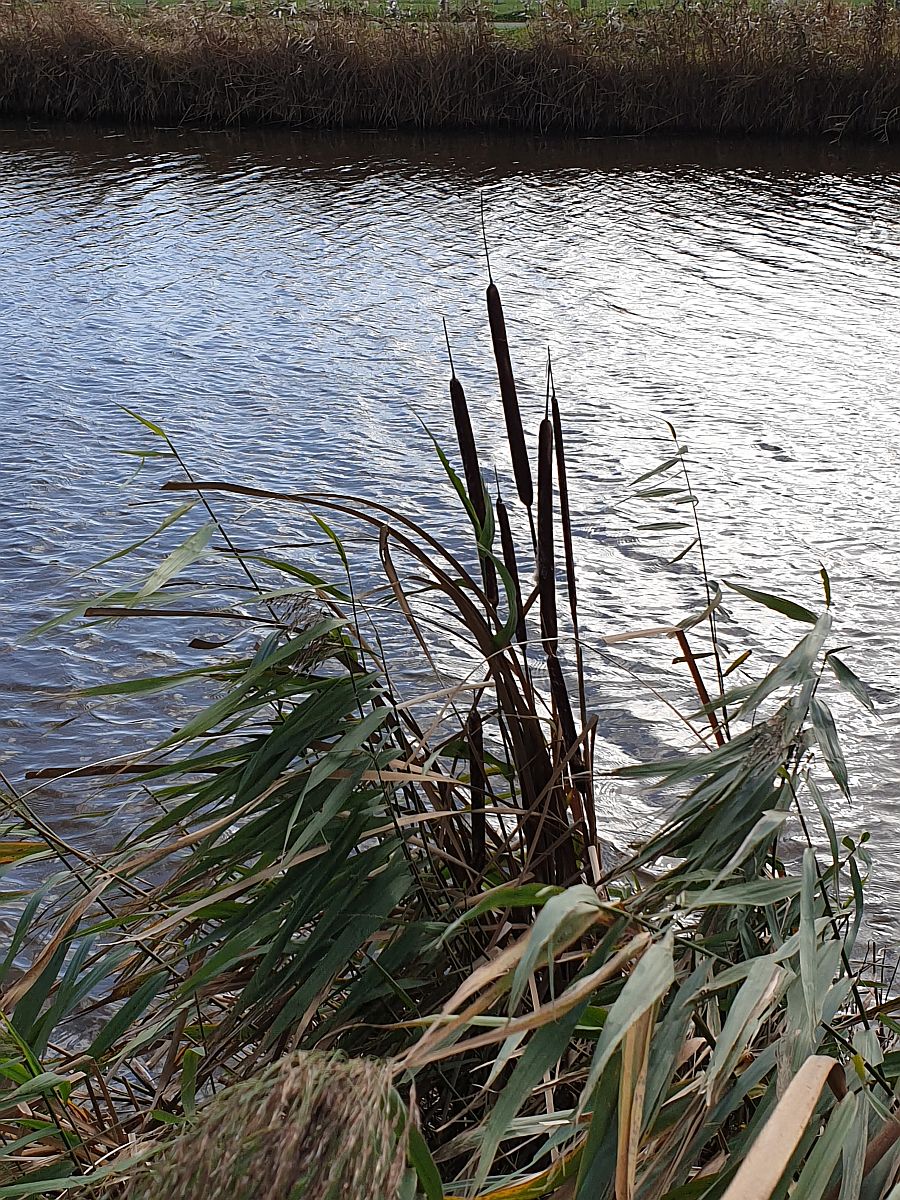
0, 128, 900, 928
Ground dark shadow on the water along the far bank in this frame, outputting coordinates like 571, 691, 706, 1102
0, 122, 900, 185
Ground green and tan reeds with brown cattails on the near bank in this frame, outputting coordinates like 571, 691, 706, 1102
0, 265, 900, 1200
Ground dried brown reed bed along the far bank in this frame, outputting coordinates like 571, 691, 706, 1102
0, 0, 900, 138
